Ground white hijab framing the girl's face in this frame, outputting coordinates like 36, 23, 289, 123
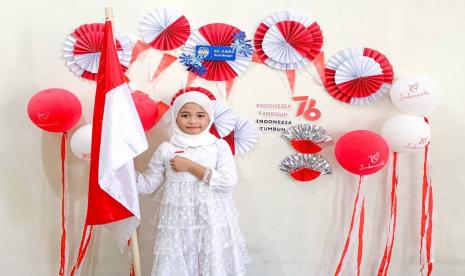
170, 91, 218, 148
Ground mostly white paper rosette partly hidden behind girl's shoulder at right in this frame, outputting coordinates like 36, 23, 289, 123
223, 118, 258, 155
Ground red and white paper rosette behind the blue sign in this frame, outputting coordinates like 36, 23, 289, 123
183, 23, 252, 81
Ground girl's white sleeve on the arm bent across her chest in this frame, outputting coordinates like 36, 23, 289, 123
202, 140, 237, 193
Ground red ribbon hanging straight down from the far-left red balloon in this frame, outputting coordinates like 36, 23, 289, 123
58, 132, 68, 276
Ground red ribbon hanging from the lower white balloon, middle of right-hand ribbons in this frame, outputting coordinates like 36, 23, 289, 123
378, 152, 398, 276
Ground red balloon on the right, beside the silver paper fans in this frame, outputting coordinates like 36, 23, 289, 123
335, 130, 389, 175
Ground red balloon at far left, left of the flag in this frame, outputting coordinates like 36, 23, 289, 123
27, 88, 82, 132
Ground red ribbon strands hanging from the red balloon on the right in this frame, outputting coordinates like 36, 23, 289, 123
334, 176, 365, 276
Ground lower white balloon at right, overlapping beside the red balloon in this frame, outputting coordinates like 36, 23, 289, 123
381, 114, 431, 152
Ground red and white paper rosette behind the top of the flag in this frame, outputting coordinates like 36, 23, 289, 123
64, 23, 134, 80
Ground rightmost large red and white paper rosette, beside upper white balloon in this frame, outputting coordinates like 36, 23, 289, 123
324, 48, 394, 105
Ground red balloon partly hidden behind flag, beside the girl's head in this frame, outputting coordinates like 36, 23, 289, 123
132, 91, 158, 131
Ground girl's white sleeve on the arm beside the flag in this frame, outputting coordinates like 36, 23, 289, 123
136, 144, 165, 195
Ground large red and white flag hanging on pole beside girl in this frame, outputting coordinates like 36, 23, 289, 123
72, 21, 148, 274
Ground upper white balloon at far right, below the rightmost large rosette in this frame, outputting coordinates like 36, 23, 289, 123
390, 76, 441, 116
